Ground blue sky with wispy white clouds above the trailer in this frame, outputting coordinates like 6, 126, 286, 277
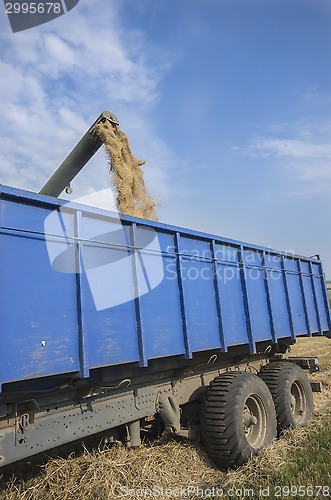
0, 0, 331, 278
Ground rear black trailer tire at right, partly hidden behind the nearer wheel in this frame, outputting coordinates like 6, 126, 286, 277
260, 361, 314, 435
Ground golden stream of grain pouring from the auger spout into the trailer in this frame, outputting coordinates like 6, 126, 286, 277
96, 121, 158, 220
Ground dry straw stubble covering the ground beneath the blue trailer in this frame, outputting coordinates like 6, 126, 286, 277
0, 338, 331, 500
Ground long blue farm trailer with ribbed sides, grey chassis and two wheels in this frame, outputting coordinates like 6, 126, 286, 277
0, 112, 331, 468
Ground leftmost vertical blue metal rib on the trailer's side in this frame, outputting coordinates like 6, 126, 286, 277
74, 211, 89, 378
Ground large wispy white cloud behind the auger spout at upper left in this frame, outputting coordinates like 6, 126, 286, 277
0, 0, 175, 203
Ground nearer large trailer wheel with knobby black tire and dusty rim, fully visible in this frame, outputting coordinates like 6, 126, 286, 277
200, 372, 277, 469
